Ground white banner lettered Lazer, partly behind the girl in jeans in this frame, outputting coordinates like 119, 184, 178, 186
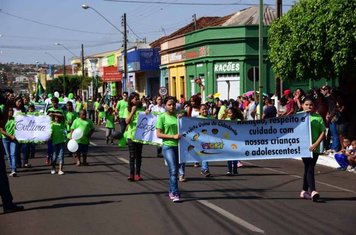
135, 112, 162, 145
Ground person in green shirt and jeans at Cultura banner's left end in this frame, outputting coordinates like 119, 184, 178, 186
0, 109, 18, 177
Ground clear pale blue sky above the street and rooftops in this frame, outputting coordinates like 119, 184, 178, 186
0, 0, 294, 64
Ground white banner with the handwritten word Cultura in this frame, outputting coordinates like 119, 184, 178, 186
15, 115, 51, 142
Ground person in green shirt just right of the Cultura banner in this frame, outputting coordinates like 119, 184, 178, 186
51, 113, 67, 175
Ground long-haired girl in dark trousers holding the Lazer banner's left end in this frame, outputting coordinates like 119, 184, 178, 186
124, 92, 144, 181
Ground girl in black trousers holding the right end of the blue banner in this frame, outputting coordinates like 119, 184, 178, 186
300, 97, 326, 202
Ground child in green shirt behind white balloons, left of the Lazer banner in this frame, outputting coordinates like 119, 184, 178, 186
70, 109, 95, 166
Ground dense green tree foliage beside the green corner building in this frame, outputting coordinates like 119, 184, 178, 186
269, 0, 356, 80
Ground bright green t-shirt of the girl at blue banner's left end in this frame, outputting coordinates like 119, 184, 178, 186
156, 113, 178, 146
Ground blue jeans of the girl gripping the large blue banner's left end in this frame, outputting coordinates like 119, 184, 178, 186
162, 145, 179, 195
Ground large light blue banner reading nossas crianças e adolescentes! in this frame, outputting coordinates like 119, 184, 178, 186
179, 113, 312, 163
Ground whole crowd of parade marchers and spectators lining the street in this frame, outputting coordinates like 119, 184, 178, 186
0, 85, 356, 212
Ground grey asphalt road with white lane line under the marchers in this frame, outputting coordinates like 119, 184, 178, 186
0, 128, 356, 235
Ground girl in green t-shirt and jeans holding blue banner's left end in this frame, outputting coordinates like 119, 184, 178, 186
156, 96, 180, 202
